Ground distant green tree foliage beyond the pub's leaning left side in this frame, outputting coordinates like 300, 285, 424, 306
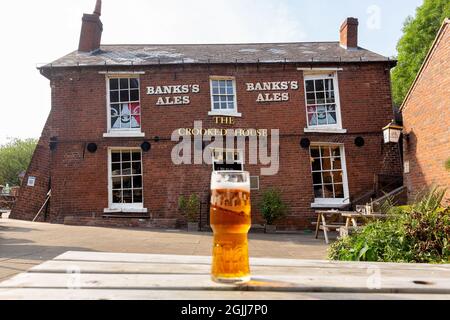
0, 139, 37, 186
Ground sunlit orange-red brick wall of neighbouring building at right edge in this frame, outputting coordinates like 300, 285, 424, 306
402, 23, 450, 205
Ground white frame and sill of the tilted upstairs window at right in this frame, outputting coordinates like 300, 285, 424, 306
303, 71, 347, 133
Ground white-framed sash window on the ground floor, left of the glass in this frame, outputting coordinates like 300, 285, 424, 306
109, 149, 143, 209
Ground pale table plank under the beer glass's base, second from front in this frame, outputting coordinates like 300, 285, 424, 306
0, 270, 450, 294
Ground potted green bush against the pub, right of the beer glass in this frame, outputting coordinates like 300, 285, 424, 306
259, 189, 287, 233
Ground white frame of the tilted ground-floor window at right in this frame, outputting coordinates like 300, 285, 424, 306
309, 142, 350, 208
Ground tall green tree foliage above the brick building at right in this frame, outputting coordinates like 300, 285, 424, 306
392, 0, 450, 106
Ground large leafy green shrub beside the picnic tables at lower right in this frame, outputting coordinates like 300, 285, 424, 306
329, 188, 450, 263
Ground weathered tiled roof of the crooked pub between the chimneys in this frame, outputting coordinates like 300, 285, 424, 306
44, 42, 392, 68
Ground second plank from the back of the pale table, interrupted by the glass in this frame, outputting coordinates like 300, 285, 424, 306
28, 260, 450, 278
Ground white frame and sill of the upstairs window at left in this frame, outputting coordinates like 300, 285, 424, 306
103, 73, 145, 138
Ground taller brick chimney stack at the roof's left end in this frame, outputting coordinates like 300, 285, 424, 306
78, 0, 103, 52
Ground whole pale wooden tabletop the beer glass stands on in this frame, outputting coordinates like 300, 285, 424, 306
0, 251, 450, 300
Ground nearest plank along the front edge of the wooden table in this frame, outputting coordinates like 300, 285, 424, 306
0, 289, 450, 301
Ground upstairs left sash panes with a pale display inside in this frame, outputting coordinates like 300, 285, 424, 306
108, 77, 141, 131
